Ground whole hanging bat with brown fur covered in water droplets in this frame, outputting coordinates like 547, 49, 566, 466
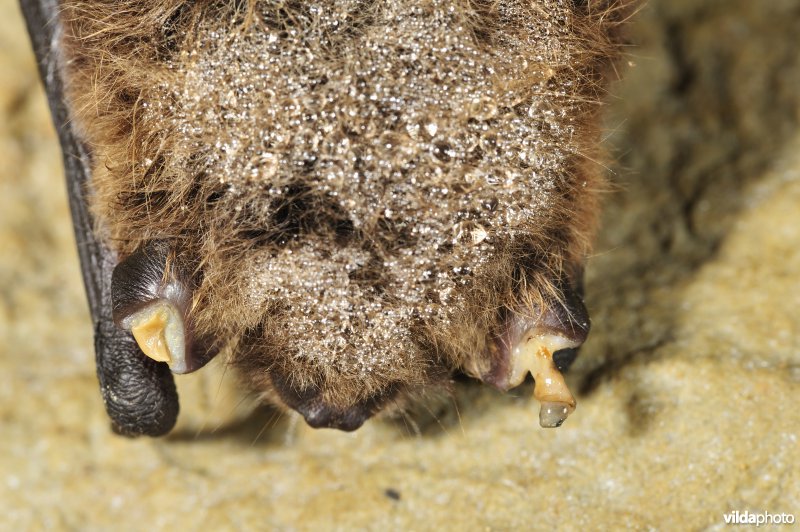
21, 0, 632, 436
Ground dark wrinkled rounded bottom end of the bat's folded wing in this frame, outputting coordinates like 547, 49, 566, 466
95, 321, 178, 437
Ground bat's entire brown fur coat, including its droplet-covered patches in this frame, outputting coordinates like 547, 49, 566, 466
56, 0, 630, 416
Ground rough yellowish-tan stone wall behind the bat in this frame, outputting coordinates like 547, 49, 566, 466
0, 0, 800, 530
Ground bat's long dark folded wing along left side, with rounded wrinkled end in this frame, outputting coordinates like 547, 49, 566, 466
20, 0, 178, 436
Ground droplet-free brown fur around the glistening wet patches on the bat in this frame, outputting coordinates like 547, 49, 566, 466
57, 0, 631, 420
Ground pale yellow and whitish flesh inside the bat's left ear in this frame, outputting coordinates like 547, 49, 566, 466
123, 299, 186, 373
